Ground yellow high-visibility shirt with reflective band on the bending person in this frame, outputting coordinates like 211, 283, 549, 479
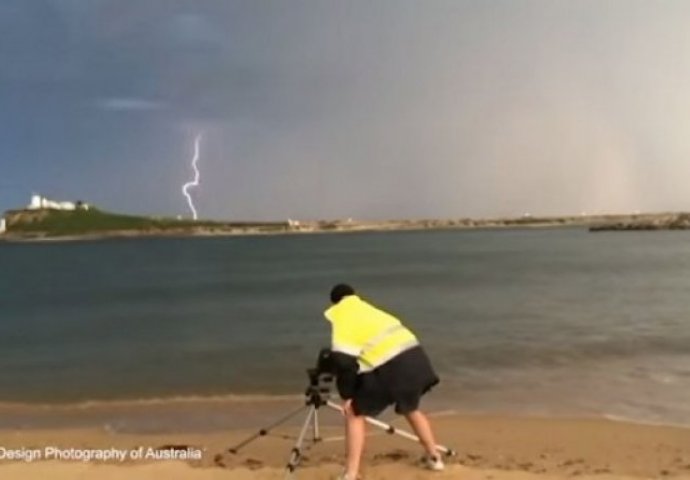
324, 295, 419, 373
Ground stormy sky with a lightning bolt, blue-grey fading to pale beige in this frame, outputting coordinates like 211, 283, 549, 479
0, 0, 690, 219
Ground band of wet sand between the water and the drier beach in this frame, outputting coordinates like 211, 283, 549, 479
0, 394, 690, 434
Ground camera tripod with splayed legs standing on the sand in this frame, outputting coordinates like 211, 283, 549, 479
228, 369, 455, 479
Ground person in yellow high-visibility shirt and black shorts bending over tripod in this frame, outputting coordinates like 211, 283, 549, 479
324, 284, 444, 480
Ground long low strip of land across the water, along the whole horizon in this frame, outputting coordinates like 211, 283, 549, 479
6, 208, 690, 240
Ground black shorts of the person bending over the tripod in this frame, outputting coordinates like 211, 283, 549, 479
352, 347, 439, 417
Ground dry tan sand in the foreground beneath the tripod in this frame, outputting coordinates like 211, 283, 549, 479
0, 414, 690, 480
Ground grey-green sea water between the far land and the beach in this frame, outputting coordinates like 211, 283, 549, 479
0, 228, 690, 428
